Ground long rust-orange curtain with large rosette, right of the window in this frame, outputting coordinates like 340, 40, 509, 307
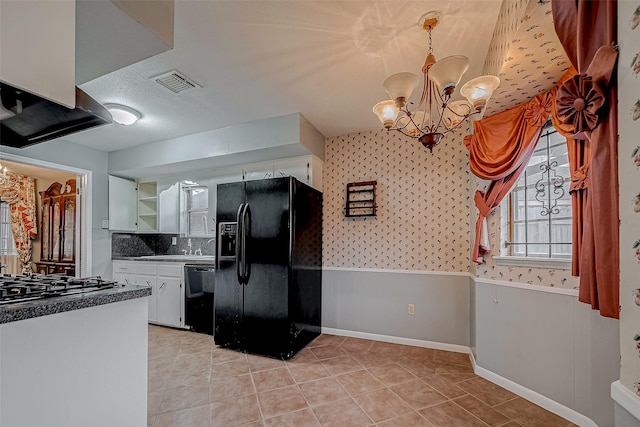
552, 0, 620, 319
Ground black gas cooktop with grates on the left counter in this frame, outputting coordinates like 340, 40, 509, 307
0, 274, 120, 304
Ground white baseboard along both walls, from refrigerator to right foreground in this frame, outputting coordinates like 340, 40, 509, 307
322, 327, 598, 427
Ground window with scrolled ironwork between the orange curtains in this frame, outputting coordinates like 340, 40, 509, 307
503, 124, 572, 259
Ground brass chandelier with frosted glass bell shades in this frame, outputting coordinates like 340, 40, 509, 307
373, 11, 500, 152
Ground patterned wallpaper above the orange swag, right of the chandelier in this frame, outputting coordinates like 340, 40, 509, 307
485, 0, 570, 116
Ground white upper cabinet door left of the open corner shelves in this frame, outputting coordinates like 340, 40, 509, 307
109, 175, 138, 231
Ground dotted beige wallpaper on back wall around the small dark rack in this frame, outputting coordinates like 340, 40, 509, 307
323, 130, 471, 272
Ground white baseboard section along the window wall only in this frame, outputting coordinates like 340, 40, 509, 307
474, 360, 598, 427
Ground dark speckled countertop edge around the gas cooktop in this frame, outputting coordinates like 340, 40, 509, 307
0, 285, 151, 324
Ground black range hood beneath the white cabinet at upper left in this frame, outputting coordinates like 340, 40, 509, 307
0, 82, 112, 148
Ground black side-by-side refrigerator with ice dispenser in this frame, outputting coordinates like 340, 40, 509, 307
214, 177, 322, 360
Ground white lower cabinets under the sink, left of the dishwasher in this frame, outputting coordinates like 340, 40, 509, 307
113, 261, 184, 328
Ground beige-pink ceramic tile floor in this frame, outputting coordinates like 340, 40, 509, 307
148, 325, 573, 427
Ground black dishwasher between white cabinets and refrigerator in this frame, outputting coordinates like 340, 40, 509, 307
184, 264, 215, 335
